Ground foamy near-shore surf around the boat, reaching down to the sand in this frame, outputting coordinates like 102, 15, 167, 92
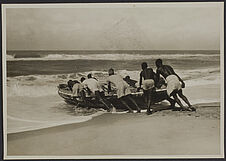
7, 68, 220, 133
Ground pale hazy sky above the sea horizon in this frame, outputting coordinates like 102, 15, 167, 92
6, 3, 223, 50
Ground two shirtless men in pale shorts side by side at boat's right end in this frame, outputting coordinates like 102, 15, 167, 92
139, 59, 196, 114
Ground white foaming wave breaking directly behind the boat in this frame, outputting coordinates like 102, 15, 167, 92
7, 68, 220, 97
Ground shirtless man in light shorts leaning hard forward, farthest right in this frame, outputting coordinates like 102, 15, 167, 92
155, 59, 196, 111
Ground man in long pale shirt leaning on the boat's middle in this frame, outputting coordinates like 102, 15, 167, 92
107, 68, 141, 113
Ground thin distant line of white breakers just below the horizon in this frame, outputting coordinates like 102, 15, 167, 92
6, 53, 220, 61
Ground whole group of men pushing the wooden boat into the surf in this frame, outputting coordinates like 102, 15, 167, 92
69, 59, 195, 114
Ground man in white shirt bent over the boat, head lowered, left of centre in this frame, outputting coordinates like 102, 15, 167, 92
82, 77, 115, 112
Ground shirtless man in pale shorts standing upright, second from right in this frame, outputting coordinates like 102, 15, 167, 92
139, 62, 155, 114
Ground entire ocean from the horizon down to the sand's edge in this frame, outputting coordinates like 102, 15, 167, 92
6, 50, 220, 133
